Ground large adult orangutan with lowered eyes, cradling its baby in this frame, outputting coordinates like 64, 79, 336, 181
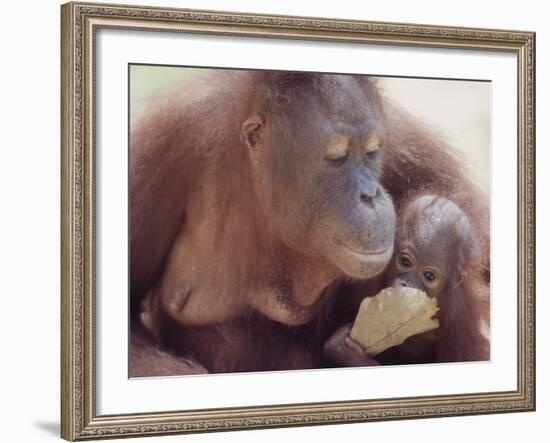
130, 71, 488, 375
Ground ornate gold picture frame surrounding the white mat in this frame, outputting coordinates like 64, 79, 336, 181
61, 2, 535, 441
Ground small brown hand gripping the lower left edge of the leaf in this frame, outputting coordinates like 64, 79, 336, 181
323, 323, 380, 366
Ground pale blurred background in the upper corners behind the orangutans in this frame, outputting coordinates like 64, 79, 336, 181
130, 65, 491, 196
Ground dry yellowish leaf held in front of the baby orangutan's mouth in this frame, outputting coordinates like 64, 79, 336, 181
350, 287, 439, 356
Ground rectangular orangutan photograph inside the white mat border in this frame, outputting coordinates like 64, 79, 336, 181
128, 64, 491, 377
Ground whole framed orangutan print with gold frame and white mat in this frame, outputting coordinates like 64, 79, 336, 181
61, 2, 535, 440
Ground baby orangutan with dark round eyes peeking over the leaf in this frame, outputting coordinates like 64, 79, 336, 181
324, 195, 489, 366
